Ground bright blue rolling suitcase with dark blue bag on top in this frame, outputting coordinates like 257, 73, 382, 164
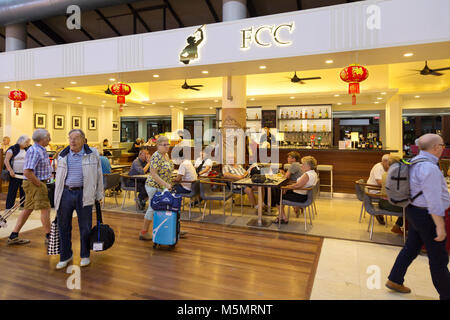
150, 190, 181, 249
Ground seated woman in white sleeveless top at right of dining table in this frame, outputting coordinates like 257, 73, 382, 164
274, 156, 317, 224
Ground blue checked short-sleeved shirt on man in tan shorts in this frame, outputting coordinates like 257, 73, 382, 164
23, 143, 52, 180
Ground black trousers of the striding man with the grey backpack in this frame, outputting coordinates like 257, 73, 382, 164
388, 205, 450, 300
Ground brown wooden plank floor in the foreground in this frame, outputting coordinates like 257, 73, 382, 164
0, 212, 322, 300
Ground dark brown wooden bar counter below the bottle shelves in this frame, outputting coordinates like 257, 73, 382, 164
138, 147, 397, 194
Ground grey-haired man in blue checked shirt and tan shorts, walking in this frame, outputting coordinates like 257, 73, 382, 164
8, 129, 52, 244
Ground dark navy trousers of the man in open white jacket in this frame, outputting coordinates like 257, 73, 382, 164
58, 189, 92, 261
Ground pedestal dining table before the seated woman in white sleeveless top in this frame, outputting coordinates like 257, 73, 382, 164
233, 174, 287, 227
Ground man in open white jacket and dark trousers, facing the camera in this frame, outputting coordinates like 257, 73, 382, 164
55, 129, 103, 269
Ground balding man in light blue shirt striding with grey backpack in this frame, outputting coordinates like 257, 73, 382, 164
386, 133, 450, 300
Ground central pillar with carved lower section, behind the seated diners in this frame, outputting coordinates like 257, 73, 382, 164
222, 76, 247, 164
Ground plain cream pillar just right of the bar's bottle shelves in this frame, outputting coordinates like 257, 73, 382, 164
383, 95, 403, 157
